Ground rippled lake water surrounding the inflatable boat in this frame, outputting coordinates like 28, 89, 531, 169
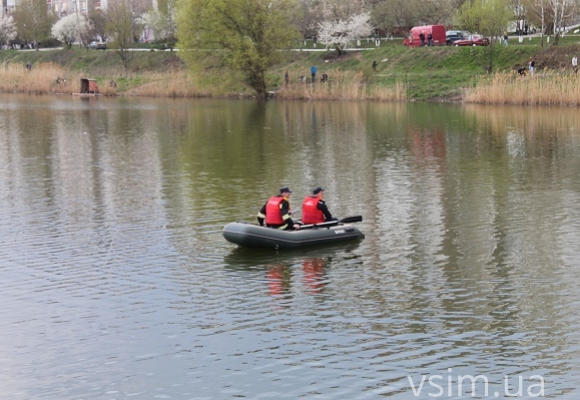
0, 95, 580, 399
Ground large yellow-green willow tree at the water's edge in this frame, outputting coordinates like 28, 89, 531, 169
177, 0, 300, 98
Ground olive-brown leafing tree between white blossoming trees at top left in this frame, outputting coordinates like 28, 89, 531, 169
14, 0, 58, 50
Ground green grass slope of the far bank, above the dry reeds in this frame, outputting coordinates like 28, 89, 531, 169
0, 36, 580, 101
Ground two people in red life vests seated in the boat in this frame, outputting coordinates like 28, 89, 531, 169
257, 186, 336, 230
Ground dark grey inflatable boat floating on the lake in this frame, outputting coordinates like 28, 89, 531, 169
222, 216, 364, 249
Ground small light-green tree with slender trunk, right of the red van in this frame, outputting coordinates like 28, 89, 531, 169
456, 0, 514, 72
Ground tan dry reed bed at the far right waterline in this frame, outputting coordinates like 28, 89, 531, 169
464, 71, 580, 106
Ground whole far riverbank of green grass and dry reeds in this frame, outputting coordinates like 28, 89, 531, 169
0, 37, 580, 102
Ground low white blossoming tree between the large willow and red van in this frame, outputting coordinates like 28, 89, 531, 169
318, 13, 373, 55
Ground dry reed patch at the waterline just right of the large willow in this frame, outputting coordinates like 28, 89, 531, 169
276, 71, 407, 101
